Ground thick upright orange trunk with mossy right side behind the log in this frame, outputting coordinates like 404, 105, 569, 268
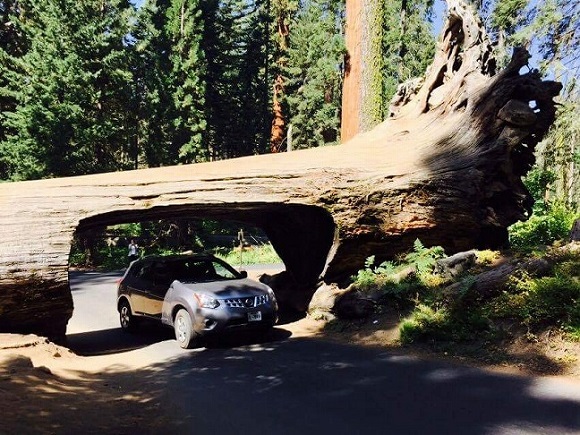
341, 0, 383, 142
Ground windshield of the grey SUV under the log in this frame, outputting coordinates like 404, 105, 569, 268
171, 258, 240, 282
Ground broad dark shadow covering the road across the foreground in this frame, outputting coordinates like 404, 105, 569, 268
0, 338, 580, 435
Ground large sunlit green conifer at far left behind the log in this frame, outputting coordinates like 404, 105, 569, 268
0, 0, 133, 179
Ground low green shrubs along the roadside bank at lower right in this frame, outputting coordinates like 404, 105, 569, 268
400, 245, 580, 343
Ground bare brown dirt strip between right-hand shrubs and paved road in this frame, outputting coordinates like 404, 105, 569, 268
299, 310, 580, 380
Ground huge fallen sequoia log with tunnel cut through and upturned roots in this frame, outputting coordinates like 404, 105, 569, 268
0, 0, 561, 336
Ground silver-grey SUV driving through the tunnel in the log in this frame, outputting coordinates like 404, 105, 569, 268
117, 254, 278, 348
